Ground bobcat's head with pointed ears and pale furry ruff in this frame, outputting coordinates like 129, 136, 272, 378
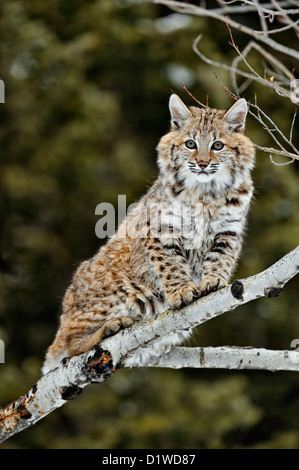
158, 95, 254, 192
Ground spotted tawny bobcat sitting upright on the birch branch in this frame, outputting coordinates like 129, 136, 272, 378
43, 95, 255, 373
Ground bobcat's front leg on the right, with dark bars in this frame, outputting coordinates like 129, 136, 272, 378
199, 231, 242, 297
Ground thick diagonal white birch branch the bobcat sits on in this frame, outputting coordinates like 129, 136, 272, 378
0, 246, 299, 442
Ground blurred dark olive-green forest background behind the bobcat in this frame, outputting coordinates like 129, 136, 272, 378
0, 0, 299, 449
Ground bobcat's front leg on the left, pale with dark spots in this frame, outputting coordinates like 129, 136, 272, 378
145, 238, 200, 308
